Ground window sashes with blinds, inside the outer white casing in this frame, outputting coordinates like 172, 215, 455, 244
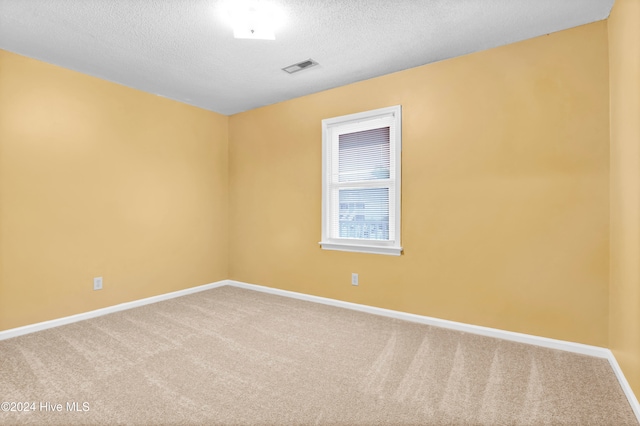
329, 117, 396, 242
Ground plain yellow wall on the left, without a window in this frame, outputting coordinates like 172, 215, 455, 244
0, 51, 228, 330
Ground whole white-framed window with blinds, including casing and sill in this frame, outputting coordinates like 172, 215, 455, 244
320, 105, 402, 256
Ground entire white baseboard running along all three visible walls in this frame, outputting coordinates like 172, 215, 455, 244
0, 280, 640, 422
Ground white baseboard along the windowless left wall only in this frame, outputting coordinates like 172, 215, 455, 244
0, 280, 228, 340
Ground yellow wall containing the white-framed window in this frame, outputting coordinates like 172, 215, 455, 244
229, 21, 609, 346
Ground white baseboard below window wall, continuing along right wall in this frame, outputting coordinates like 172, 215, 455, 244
227, 280, 640, 422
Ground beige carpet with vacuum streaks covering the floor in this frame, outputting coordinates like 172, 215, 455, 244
0, 287, 638, 426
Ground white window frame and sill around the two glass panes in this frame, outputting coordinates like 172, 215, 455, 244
320, 105, 402, 256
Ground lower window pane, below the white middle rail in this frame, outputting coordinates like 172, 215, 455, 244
339, 188, 389, 240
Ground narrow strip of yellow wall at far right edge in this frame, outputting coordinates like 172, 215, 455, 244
608, 0, 640, 396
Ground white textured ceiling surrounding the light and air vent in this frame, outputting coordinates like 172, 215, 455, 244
0, 0, 613, 115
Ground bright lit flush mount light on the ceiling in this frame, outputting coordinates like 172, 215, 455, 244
224, 0, 282, 40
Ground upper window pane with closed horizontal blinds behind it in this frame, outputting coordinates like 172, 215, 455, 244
338, 126, 391, 182
